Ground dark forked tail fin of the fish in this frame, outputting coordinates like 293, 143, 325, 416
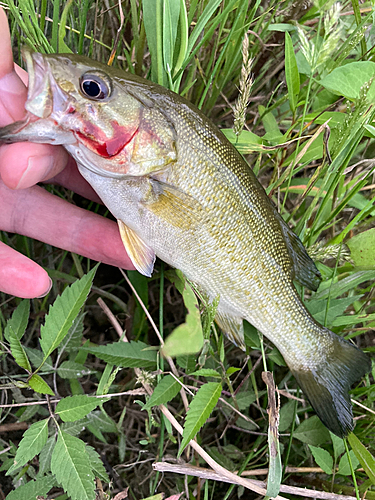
293, 330, 371, 438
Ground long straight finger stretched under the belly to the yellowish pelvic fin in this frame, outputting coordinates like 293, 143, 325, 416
0, 182, 134, 269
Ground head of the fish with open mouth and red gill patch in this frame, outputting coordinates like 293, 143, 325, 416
0, 49, 177, 178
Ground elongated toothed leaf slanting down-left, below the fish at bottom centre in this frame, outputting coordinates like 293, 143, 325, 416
178, 382, 222, 456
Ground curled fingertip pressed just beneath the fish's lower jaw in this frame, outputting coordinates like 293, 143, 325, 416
0, 142, 69, 189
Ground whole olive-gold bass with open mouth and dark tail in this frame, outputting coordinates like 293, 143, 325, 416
0, 50, 371, 437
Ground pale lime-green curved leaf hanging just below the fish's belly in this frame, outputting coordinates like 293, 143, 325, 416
162, 281, 204, 357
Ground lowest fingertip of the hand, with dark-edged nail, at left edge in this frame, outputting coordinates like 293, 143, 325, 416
0, 242, 52, 299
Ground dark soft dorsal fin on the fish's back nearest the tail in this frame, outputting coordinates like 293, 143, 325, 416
274, 207, 322, 292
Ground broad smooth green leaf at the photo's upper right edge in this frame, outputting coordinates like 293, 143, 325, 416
319, 61, 375, 103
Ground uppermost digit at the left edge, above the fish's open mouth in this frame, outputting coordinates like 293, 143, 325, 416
0, 8, 27, 126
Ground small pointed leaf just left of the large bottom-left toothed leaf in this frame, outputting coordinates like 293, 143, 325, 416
6, 418, 49, 475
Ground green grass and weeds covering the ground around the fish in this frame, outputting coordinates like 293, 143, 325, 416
0, 0, 375, 500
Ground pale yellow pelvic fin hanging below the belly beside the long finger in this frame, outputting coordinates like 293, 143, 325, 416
117, 223, 155, 277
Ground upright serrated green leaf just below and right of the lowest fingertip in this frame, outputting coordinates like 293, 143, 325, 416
40, 266, 98, 360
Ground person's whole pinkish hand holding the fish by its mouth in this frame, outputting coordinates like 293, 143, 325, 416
0, 8, 134, 298
